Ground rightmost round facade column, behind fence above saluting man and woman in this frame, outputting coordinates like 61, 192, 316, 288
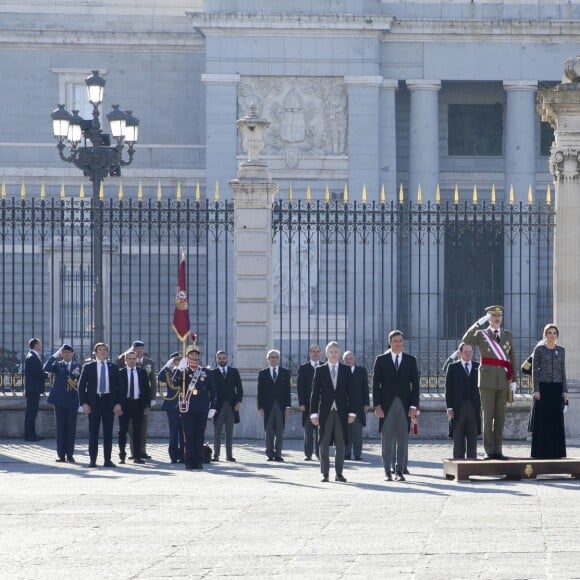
503, 81, 538, 344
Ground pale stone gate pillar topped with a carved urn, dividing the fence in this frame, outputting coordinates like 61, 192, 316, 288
230, 107, 278, 437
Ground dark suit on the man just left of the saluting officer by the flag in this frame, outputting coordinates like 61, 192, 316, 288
119, 367, 151, 461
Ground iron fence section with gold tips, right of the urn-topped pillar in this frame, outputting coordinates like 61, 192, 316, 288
273, 200, 555, 392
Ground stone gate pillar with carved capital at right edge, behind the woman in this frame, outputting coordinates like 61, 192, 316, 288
538, 56, 580, 437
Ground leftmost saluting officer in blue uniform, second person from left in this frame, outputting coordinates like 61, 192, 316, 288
44, 344, 81, 463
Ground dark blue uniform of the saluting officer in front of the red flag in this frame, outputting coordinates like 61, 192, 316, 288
173, 367, 217, 469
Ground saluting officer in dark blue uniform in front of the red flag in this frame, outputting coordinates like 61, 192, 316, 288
173, 344, 217, 469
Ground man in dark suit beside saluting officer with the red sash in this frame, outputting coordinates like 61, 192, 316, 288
445, 342, 481, 459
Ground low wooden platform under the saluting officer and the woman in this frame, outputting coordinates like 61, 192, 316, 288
443, 458, 580, 481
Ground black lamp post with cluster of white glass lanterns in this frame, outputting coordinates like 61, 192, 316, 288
52, 70, 139, 343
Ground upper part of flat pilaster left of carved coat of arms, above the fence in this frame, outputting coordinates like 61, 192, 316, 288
201, 74, 240, 199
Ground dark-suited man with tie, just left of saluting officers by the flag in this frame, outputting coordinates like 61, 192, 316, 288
119, 351, 151, 464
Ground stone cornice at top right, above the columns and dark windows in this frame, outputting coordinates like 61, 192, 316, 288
383, 18, 580, 42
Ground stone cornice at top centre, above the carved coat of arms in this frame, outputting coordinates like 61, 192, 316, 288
186, 12, 395, 33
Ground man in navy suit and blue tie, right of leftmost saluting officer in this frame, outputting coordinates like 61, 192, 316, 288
79, 342, 121, 467
